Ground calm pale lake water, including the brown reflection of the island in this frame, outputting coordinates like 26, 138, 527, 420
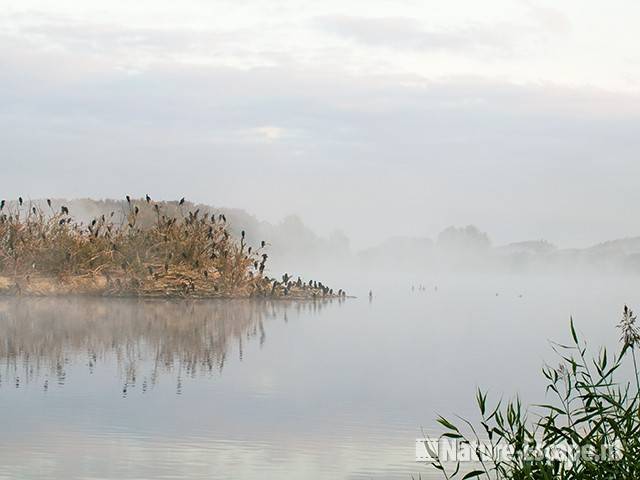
0, 275, 640, 480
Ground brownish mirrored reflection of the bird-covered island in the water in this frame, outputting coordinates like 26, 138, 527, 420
0, 298, 340, 388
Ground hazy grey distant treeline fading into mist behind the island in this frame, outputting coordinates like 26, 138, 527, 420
10, 199, 640, 274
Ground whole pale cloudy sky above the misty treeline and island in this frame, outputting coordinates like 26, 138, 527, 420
0, 0, 640, 247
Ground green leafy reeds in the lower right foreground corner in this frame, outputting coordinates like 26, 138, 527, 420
424, 306, 640, 480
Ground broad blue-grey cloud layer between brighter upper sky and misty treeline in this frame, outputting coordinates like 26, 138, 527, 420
0, 28, 640, 247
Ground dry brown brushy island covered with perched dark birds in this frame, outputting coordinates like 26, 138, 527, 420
0, 195, 345, 298
